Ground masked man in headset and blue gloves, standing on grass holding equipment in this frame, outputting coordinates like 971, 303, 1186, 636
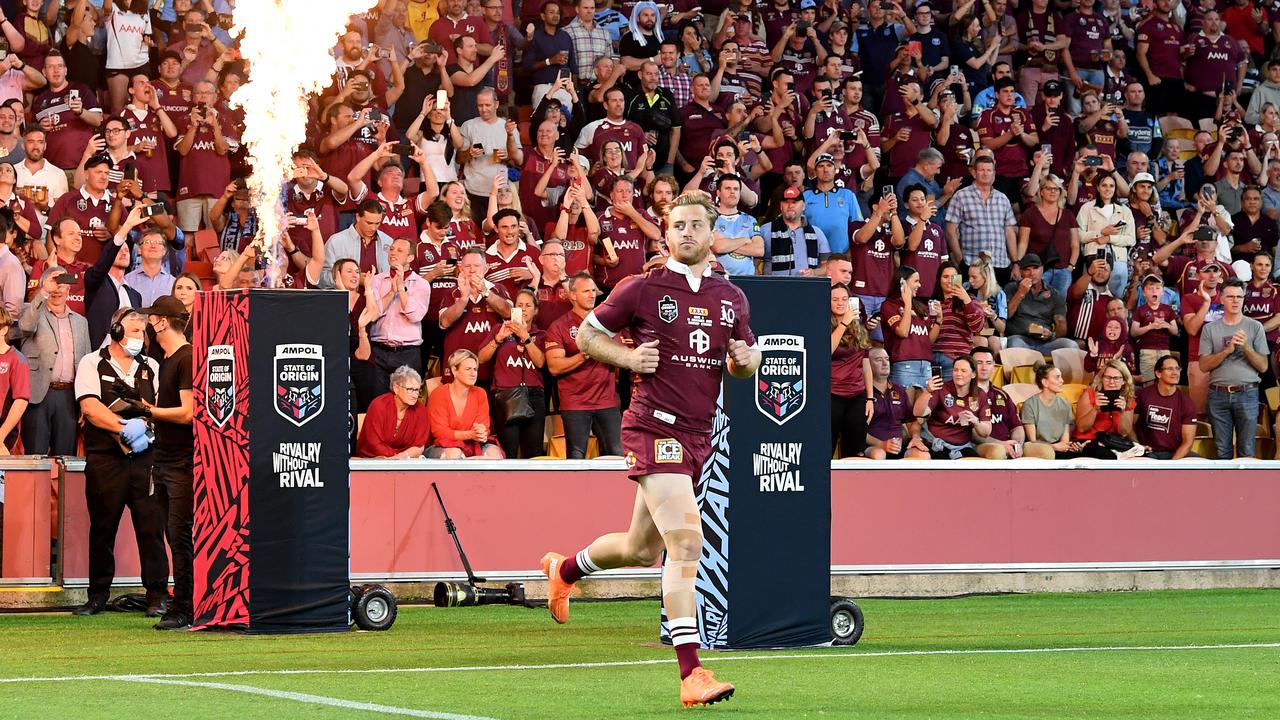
76, 307, 169, 616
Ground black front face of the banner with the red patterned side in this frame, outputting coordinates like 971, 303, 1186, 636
248, 290, 351, 633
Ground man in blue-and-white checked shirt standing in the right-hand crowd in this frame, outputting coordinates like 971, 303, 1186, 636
947, 156, 1018, 275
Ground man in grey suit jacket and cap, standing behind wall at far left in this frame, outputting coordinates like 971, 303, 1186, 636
18, 265, 90, 455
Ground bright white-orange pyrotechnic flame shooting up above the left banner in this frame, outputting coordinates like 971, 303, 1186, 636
230, 0, 375, 286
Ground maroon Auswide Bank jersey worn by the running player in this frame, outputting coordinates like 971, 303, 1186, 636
589, 260, 755, 434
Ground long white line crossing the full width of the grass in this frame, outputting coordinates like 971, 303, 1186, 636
0, 642, 1280, 689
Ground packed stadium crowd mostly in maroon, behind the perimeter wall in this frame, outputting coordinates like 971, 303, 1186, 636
0, 0, 1280, 459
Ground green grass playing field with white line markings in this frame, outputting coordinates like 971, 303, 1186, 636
0, 591, 1280, 720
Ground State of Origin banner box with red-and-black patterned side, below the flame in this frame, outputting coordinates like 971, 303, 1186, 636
193, 290, 349, 633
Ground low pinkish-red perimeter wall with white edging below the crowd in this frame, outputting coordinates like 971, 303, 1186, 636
0, 457, 1280, 588
